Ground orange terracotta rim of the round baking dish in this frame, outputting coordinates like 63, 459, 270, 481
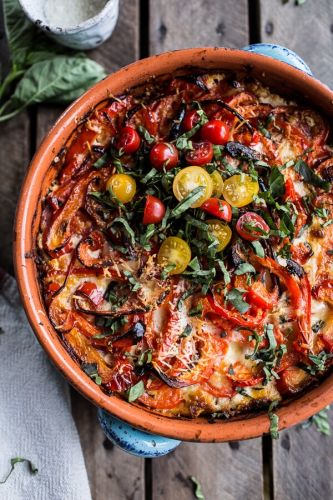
14, 48, 333, 442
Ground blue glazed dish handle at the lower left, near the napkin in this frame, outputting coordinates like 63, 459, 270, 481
98, 409, 181, 458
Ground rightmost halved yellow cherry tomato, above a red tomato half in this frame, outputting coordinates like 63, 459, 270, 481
223, 174, 259, 207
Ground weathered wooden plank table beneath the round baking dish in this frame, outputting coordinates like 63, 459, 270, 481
0, 0, 333, 500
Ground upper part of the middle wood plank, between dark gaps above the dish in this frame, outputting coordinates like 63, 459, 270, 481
150, 0, 249, 54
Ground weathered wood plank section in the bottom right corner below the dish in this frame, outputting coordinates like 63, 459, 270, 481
273, 411, 333, 500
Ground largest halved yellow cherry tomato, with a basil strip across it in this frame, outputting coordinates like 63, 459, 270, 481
172, 166, 213, 208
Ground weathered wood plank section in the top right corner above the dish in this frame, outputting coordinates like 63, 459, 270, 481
260, 0, 333, 87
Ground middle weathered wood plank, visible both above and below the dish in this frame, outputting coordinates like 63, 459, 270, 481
150, 0, 263, 500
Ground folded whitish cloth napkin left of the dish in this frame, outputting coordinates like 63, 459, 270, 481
0, 273, 91, 500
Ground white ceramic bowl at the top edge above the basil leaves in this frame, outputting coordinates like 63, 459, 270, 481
19, 0, 119, 50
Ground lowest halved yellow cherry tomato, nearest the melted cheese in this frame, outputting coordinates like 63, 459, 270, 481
157, 236, 191, 274
